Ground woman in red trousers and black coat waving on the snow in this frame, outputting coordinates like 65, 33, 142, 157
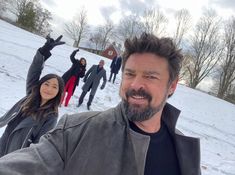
61, 49, 86, 106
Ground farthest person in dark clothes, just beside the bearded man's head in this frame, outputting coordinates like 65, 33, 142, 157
109, 56, 122, 83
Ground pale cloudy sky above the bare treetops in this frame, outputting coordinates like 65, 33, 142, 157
40, 0, 235, 38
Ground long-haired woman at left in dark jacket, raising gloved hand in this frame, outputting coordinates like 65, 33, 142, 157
0, 36, 64, 157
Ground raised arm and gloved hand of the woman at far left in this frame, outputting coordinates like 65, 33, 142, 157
26, 35, 65, 95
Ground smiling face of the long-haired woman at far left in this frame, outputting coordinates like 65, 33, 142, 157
40, 78, 59, 105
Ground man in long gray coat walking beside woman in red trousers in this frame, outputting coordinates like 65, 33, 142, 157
77, 60, 107, 110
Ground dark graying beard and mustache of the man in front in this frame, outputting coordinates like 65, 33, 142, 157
123, 89, 167, 122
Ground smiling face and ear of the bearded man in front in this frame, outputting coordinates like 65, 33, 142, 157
120, 53, 177, 121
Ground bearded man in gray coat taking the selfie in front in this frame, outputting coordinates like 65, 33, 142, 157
0, 33, 201, 175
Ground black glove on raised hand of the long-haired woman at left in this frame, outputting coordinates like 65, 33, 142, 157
39, 35, 65, 61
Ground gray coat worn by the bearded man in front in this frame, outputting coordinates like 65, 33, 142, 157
0, 104, 201, 175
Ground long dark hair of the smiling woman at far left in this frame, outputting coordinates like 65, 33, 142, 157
22, 74, 64, 120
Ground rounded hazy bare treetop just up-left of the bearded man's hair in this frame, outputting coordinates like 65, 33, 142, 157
116, 15, 144, 43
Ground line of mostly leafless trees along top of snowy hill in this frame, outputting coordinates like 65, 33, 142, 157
0, 0, 235, 103
